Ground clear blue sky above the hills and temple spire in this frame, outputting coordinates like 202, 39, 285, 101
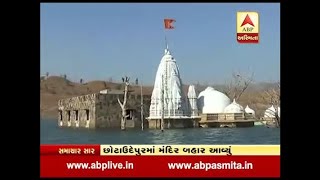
40, 3, 280, 85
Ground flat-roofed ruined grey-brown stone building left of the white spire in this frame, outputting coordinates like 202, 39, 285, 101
58, 89, 150, 129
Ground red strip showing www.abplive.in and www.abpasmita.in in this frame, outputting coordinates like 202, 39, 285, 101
40, 155, 280, 177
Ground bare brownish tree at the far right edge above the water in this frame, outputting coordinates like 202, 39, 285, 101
262, 82, 280, 127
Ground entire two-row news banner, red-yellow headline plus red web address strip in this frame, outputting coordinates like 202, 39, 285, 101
40, 145, 280, 177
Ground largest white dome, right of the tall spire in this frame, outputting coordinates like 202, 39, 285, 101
198, 87, 230, 114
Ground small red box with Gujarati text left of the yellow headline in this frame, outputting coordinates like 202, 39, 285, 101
40, 144, 100, 157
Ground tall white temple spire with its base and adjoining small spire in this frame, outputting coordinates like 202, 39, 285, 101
147, 45, 198, 129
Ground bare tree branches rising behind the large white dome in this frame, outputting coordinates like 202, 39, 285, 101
223, 70, 254, 101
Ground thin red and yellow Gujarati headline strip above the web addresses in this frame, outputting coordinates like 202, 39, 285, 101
40, 145, 280, 156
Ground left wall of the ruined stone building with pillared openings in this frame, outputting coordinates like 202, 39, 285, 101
58, 94, 96, 128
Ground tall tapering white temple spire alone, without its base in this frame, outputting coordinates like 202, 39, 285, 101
148, 46, 190, 119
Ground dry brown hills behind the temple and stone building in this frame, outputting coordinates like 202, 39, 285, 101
40, 76, 275, 118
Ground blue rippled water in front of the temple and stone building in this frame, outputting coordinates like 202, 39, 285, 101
40, 120, 280, 144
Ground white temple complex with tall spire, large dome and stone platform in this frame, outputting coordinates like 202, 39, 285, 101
147, 43, 255, 130
